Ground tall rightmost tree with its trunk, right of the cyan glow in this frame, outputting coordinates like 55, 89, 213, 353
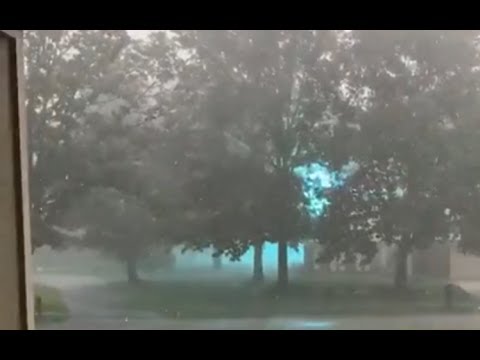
316, 31, 478, 288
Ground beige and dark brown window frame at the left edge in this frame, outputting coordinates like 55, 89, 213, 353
0, 30, 34, 330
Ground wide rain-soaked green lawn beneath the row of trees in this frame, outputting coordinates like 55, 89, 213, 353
106, 272, 479, 318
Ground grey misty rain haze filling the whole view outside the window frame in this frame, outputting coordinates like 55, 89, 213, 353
29, 30, 480, 330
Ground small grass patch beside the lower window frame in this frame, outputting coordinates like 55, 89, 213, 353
35, 284, 68, 323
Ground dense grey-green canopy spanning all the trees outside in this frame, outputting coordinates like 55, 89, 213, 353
25, 30, 480, 287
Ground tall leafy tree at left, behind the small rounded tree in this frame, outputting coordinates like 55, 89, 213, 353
26, 30, 186, 266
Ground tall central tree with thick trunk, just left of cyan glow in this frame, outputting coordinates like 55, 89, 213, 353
169, 30, 360, 286
